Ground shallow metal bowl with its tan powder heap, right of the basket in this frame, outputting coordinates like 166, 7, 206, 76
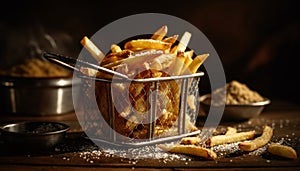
199, 80, 271, 121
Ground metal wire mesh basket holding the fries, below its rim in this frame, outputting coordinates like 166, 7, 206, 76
81, 72, 204, 146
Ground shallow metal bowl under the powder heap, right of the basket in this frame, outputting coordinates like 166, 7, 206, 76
199, 94, 271, 121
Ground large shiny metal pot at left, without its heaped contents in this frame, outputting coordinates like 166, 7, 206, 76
0, 76, 80, 116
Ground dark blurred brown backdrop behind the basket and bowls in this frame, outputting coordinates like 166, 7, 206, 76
0, 0, 300, 104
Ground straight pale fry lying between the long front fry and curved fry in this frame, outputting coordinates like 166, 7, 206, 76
206, 131, 255, 147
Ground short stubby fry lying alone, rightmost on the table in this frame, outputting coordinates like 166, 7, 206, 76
267, 143, 297, 159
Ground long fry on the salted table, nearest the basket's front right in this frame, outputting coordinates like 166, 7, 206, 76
157, 144, 217, 160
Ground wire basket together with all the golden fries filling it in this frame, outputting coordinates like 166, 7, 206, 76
80, 26, 209, 142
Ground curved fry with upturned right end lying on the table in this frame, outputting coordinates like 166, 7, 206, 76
239, 125, 273, 151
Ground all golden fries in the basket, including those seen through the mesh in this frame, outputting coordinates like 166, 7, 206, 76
80, 26, 209, 138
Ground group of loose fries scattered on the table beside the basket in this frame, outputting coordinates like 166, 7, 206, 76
158, 125, 297, 160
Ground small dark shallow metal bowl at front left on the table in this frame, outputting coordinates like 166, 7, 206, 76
0, 122, 70, 148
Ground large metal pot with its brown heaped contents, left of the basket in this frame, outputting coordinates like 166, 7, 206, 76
0, 58, 80, 116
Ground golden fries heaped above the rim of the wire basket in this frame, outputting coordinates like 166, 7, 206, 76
81, 26, 209, 78
